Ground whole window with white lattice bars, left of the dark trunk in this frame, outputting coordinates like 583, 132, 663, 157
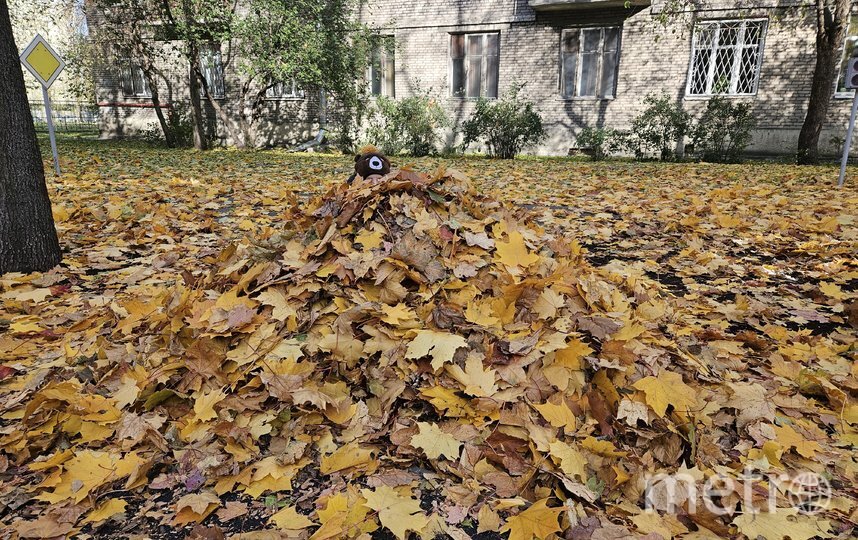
688, 20, 766, 96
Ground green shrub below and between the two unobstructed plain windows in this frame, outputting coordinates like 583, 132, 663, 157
462, 85, 545, 159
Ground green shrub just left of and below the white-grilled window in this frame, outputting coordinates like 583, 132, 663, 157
627, 94, 690, 160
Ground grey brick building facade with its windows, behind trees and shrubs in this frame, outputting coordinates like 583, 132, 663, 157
93, 0, 858, 155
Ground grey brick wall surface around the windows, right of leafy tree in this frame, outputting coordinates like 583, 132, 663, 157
360, 0, 850, 154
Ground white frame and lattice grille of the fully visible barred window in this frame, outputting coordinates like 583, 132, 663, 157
685, 18, 769, 99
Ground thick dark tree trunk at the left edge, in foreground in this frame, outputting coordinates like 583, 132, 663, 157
0, 0, 62, 274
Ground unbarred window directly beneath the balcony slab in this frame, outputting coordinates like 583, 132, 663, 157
560, 26, 621, 98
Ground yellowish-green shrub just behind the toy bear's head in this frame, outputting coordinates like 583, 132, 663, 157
366, 91, 451, 156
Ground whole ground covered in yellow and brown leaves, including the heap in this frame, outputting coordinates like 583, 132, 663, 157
0, 142, 858, 540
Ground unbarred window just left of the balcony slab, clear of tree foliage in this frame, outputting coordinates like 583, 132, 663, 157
450, 33, 500, 98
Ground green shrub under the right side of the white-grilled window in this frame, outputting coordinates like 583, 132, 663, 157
691, 96, 756, 163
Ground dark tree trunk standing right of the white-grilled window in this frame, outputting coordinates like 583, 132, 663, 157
796, 0, 851, 165
